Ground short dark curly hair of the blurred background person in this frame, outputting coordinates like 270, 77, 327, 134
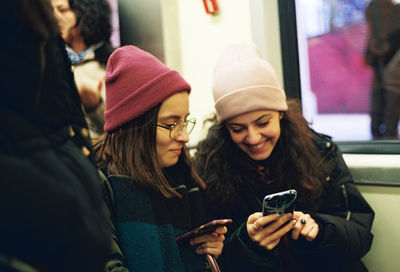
68, 0, 112, 47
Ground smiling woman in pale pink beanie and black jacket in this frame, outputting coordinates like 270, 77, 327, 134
194, 44, 374, 272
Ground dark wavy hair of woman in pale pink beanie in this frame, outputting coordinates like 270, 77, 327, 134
194, 100, 324, 210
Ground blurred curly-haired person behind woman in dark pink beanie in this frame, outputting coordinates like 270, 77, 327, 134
51, 0, 113, 137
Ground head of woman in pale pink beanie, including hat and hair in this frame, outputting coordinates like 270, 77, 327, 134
196, 44, 321, 204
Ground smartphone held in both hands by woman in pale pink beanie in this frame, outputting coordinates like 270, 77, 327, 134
262, 189, 297, 216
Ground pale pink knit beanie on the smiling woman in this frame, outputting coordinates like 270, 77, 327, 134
213, 44, 288, 122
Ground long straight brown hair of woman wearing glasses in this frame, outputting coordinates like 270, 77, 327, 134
93, 104, 205, 198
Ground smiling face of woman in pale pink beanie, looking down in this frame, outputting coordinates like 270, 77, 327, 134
225, 110, 283, 161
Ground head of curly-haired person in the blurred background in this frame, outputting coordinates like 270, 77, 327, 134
51, 0, 112, 53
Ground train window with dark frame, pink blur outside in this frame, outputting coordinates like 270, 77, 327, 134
278, 0, 400, 153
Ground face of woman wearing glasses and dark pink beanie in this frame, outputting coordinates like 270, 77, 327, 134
156, 92, 189, 168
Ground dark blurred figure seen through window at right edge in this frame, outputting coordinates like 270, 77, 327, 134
365, 0, 400, 140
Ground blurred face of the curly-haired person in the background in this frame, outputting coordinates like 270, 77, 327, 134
51, 0, 77, 44
